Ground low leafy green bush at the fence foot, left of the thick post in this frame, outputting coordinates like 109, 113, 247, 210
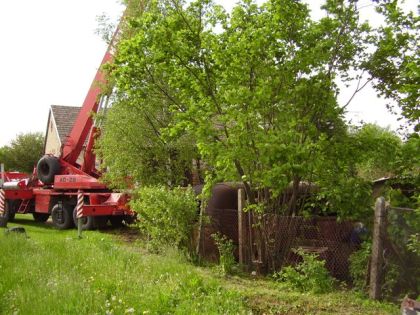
274, 249, 335, 293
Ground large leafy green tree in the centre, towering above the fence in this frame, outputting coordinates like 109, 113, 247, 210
100, 0, 412, 215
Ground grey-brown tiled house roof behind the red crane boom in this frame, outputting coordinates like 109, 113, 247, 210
51, 105, 81, 143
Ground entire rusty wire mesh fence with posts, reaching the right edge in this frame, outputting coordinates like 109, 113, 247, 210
194, 185, 420, 301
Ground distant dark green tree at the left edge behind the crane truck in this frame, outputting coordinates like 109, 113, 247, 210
0, 132, 44, 173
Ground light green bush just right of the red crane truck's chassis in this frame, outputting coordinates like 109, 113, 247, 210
131, 186, 198, 251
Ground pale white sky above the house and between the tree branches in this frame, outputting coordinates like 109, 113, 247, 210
0, 0, 418, 146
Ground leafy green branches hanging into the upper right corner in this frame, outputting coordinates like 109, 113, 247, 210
361, 0, 420, 131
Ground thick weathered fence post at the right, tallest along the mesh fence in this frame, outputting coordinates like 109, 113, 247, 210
369, 197, 386, 300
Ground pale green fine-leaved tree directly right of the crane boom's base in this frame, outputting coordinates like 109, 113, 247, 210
96, 92, 196, 188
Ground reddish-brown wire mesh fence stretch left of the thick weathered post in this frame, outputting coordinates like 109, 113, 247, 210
200, 208, 360, 281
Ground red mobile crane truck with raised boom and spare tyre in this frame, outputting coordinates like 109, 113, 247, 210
0, 21, 135, 229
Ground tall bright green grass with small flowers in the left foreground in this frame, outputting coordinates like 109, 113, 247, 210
0, 217, 245, 314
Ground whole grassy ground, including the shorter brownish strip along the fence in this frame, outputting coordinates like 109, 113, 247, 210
0, 216, 397, 314
